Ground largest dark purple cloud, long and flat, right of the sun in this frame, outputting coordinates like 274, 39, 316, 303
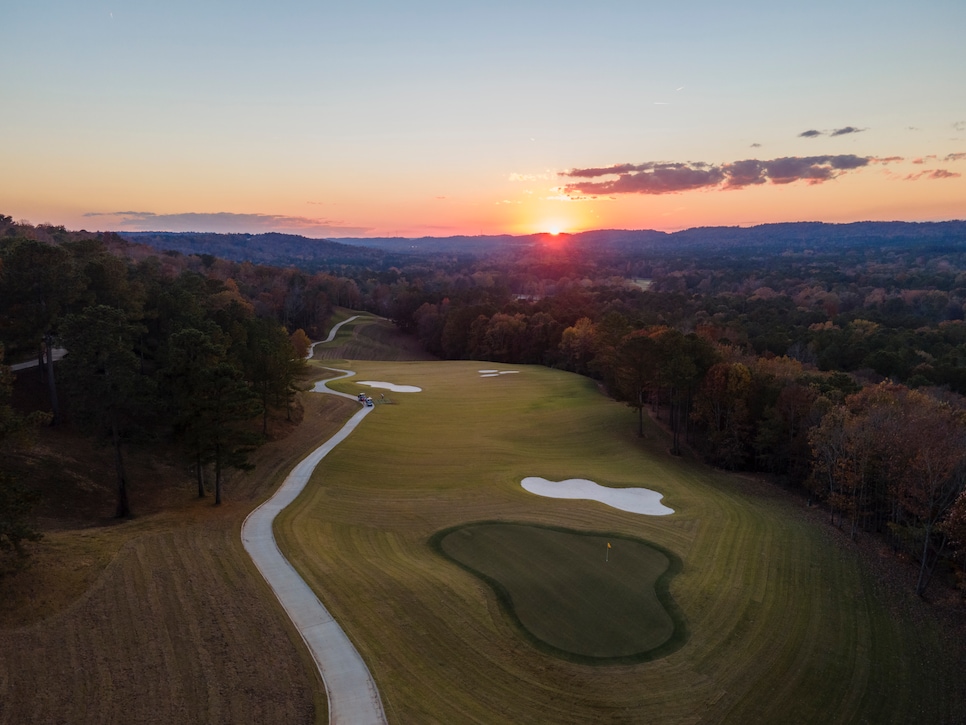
561, 154, 878, 196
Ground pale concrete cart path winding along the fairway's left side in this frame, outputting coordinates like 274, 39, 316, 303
242, 368, 386, 725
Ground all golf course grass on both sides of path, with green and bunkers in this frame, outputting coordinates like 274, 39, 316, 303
0, 311, 966, 725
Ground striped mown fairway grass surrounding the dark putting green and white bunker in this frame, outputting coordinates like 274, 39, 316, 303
276, 362, 966, 723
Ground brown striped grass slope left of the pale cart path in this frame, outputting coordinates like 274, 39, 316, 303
0, 366, 364, 725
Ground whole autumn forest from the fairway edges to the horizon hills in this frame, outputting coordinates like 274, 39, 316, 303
0, 212, 966, 596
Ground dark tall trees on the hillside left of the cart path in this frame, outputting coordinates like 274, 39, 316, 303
0, 217, 318, 548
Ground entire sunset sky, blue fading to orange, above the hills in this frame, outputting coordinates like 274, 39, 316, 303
0, 0, 966, 238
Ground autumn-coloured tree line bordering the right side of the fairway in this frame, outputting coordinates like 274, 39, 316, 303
392, 274, 966, 594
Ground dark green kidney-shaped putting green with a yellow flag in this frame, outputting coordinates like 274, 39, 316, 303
431, 522, 687, 664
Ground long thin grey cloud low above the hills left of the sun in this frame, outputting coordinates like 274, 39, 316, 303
84, 211, 371, 237
